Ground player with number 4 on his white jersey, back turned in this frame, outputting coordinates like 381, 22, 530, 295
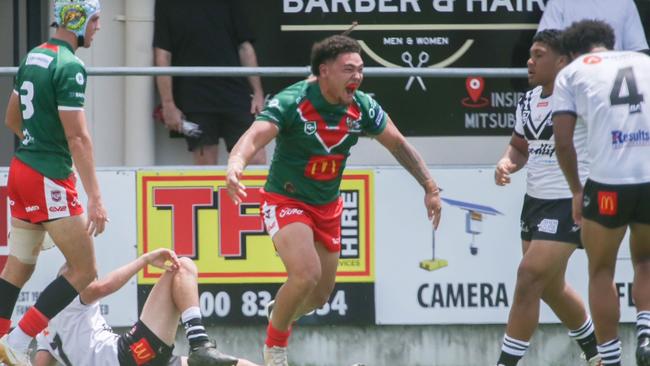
553, 21, 650, 366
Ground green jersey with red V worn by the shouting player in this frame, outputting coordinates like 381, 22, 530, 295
256, 80, 388, 205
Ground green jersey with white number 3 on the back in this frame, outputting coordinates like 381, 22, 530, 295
14, 39, 86, 179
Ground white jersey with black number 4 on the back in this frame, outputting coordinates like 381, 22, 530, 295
553, 51, 650, 184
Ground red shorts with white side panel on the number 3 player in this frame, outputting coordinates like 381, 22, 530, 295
7, 158, 83, 224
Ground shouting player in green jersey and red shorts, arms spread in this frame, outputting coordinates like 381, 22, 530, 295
226, 36, 440, 366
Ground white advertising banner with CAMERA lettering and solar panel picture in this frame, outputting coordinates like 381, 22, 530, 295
375, 168, 636, 324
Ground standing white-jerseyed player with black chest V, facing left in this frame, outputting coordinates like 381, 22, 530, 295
494, 29, 600, 366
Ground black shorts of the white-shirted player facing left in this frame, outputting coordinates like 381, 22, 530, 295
521, 195, 582, 248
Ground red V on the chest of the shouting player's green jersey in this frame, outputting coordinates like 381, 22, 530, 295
298, 99, 361, 150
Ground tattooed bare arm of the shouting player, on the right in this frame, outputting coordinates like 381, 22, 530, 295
377, 118, 441, 228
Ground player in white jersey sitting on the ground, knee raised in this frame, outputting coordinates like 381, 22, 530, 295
34, 249, 248, 366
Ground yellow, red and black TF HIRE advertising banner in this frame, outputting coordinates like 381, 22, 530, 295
137, 170, 375, 324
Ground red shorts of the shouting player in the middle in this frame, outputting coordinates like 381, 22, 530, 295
260, 189, 343, 252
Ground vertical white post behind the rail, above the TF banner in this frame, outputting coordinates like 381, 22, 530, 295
124, 0, 155, 166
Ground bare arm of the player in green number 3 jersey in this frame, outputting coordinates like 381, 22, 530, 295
59, 110, 108, 236
